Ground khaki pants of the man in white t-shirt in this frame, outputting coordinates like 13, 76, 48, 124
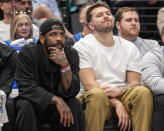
79, 86, 153, 131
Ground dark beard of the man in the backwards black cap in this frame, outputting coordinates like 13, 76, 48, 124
44, 41, 64, 55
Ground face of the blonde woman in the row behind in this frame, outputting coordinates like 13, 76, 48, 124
16, 17, 31, 39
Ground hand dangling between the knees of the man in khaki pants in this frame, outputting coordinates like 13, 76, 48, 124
116, 103, 131, 131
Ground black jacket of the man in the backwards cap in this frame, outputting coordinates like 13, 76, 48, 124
16, 43, 80, 111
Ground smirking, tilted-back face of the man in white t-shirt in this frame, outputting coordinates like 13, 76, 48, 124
89, 7, 114, 32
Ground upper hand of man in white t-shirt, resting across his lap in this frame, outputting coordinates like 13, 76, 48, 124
100, 85, 122, 97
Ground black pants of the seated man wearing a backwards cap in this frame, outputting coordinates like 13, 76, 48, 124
16, 98, 85, 131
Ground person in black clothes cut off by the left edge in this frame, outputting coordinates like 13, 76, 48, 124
0, 42, 17, 131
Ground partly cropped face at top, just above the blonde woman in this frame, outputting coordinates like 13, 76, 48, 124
20, 0, 32, 12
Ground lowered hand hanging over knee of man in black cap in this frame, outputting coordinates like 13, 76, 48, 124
53, 96, 74, 127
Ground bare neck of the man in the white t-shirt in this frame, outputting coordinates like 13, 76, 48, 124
93, 31, 114, 47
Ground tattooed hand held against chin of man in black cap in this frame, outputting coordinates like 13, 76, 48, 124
48, 47, 69, 67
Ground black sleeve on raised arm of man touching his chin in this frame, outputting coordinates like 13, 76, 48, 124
58, 46, 80, 98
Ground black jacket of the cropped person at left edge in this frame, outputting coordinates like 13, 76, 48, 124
0, 43, 17, 96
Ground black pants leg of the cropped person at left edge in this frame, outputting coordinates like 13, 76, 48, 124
2, 99, 16, 131
